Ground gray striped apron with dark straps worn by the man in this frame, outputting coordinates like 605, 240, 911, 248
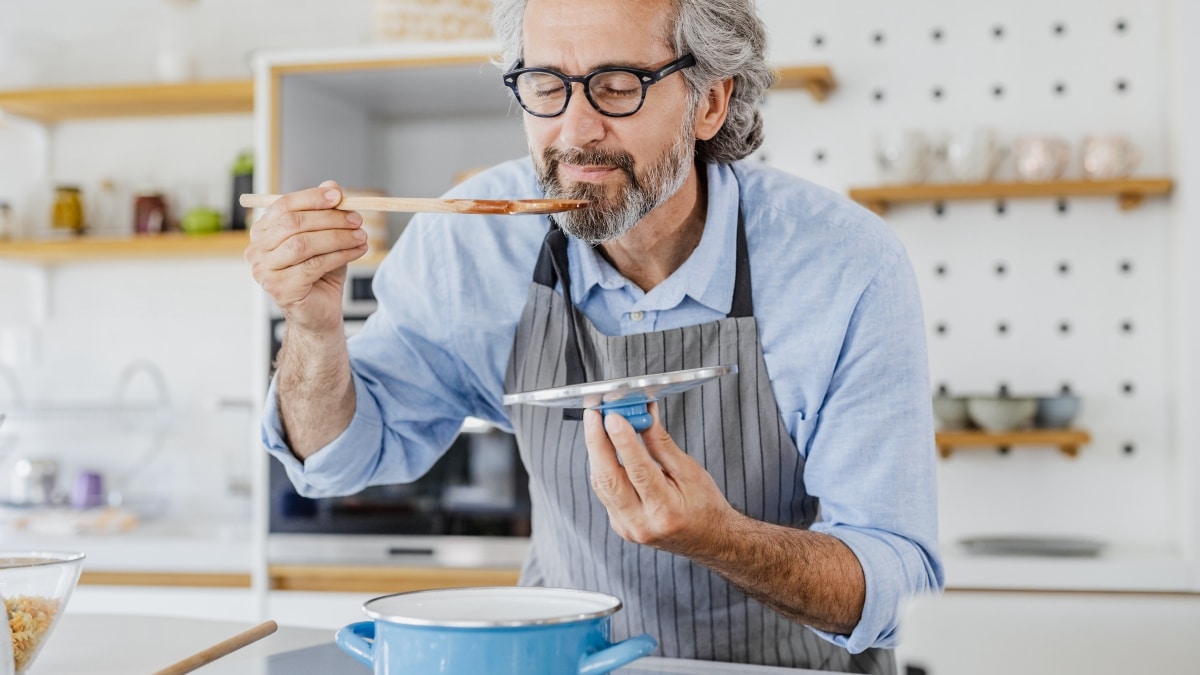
505, 217, 895, 674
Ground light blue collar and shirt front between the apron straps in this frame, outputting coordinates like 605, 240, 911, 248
569, 163, 738, 313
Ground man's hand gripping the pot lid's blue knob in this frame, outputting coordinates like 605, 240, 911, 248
583, 402, 740, 557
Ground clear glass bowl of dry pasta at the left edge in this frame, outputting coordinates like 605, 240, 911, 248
0, 551, 84, 675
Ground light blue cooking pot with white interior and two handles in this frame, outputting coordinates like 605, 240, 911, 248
335, 586, 659, 675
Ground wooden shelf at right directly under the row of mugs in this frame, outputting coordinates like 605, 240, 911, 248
850, 178, 1174, 215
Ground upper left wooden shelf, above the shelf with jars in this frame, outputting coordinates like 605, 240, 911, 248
0, 79, 254, 124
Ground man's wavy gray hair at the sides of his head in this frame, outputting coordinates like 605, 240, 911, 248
492, 0, 775, 163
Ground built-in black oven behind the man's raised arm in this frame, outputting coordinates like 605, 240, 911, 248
268, 265, 530, 567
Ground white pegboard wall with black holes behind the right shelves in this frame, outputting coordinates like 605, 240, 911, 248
758, 0, 1188, 559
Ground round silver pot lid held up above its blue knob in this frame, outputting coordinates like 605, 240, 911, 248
504, 364, 738, 408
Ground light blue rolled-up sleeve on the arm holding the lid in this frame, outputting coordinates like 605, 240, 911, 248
805, 248, 944, 652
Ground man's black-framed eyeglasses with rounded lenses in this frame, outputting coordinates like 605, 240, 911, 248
504, 54, 696, 118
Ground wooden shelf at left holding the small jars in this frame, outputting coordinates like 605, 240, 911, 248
0, 231, 250, 264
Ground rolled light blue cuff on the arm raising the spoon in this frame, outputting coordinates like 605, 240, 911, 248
262, 375, 383, 498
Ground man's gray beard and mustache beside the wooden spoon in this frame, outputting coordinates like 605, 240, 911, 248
535, 124, 696, 246
